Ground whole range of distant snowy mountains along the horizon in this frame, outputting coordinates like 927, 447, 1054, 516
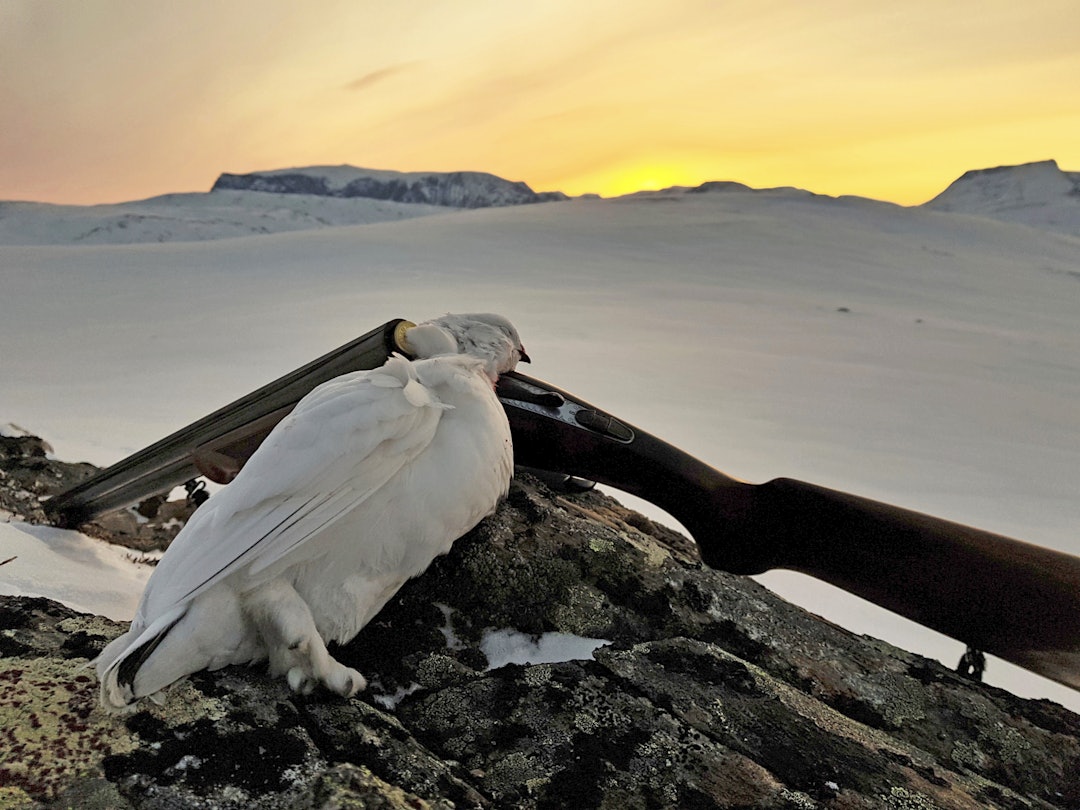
0, 160, 1080, 245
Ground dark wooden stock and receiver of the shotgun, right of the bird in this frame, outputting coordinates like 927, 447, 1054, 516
499, 373, 1080, 689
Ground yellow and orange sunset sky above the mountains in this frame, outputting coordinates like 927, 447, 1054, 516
0, 0, 1080, 204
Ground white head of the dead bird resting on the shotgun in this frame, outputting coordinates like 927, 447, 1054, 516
408, 313, 529, 381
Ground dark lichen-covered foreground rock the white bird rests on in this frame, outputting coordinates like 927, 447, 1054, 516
0, 440, 1080, 809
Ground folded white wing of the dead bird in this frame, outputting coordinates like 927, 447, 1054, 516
133, 357, 448, 629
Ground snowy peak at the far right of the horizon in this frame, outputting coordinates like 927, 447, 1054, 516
922, 160, 1080, 235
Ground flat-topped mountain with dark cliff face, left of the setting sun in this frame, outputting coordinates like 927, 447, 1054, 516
214, 165, 568, 208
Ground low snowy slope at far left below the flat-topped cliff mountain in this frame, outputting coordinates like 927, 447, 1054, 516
0, 190, 447, 245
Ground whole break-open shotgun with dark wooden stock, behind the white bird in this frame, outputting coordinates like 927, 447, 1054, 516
44, 319, 1080, 689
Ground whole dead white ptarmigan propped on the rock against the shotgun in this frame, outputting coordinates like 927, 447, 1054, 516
95, 314, 528, 711
